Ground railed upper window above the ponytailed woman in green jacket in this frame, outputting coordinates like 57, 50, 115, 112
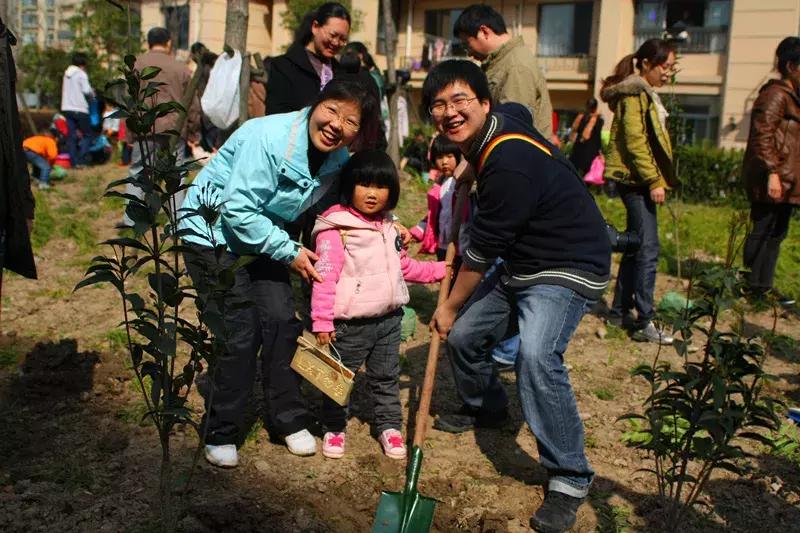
635, 0, 731, 54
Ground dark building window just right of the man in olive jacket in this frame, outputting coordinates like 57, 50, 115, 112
537, 2, 594, 57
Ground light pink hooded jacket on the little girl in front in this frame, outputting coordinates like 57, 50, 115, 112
311, 205, 446, 333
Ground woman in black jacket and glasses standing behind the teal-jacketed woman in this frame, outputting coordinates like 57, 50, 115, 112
266, 2, 350, 115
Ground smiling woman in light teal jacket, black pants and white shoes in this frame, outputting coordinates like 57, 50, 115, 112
180, 79, 378, 467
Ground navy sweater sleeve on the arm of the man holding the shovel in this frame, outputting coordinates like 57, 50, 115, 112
462, 164, 536, 272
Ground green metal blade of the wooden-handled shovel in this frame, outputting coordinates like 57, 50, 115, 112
372, 446, 436, 533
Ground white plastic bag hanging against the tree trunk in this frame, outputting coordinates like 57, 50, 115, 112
200, 50, 242, 130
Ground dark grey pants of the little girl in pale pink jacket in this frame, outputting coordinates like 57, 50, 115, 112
322, 309, 403, 434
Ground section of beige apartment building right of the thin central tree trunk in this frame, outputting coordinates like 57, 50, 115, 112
392, 0, 800, 147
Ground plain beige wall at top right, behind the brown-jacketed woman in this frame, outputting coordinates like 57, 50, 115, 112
719, 0, 800, 147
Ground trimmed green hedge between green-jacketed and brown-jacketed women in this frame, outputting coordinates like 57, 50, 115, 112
674, 143, 746, 204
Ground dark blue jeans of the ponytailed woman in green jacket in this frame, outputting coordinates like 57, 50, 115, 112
611, 184, 660, 329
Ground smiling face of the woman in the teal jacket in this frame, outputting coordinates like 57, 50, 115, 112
308, 100, 361, 152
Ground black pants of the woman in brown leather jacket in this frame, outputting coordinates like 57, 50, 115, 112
744, 203, 793, 290
